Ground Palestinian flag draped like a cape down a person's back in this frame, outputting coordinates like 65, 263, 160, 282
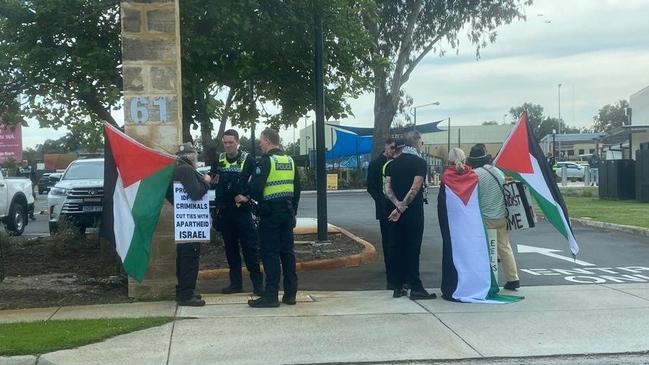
437, 166, 522, 304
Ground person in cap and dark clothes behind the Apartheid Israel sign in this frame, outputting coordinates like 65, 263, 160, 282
167, 143, 210, 307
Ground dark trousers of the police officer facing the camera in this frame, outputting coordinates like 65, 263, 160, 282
218, 206, 264, 289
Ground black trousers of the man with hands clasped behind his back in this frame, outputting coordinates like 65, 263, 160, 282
388, 207, 424, 290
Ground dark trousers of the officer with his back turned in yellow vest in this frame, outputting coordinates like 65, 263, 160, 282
259, 209, 297, 299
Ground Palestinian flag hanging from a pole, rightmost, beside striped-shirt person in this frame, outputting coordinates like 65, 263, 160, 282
494, 111, 579, 255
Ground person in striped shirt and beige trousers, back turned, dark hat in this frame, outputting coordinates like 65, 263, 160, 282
469, 144, 520, 290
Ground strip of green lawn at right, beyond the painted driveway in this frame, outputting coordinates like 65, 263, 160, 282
564, 196, 649, 228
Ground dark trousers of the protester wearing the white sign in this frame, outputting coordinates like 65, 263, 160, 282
176, 242, 201, 301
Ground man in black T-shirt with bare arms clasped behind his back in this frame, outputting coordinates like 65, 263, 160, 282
385, 131, 436, 300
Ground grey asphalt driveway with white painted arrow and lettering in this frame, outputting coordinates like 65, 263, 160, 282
25, 190, 649, 290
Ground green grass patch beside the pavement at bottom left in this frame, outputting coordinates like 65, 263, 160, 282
0, 317, 173, 356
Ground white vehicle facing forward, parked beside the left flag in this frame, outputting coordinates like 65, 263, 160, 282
47, 158, 104, 234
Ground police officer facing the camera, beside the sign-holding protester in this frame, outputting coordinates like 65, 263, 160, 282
211, 129, 263, 295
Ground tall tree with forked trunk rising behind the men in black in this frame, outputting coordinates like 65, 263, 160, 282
362, 0, 532, 155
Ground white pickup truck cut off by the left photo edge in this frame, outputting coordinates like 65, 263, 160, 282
0, 171, 34, 236
